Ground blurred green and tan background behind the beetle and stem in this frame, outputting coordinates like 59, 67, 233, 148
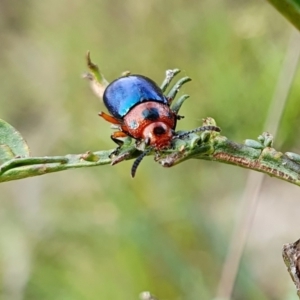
0, 0, 300, 300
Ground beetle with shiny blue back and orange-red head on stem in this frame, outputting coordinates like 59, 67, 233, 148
99, 70, 220, 177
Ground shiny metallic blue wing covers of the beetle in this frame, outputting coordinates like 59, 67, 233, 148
103, 75, 168, 119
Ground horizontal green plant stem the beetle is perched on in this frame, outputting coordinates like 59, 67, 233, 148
0, 132, 300, 186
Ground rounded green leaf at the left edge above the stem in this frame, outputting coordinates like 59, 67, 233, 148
0, 119, 29, 164
